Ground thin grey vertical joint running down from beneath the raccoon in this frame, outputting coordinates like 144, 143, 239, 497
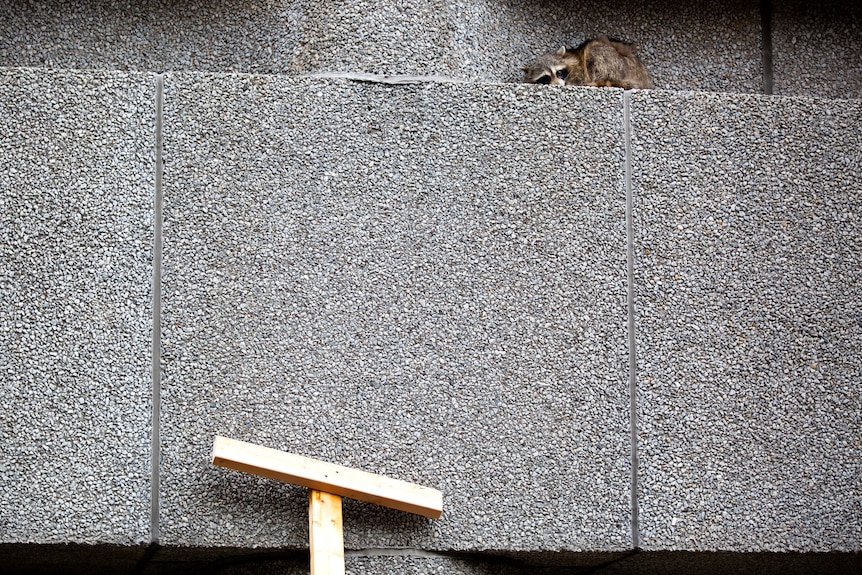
623, 90, 640, 549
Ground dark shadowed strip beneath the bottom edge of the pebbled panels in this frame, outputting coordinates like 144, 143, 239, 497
0, 545, 862, 575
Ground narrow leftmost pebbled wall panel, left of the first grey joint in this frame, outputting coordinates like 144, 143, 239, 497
0, 69, 155, 544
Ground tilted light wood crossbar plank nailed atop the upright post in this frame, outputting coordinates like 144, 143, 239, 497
212, 436, 443, 519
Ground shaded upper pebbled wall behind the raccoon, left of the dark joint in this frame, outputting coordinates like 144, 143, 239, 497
0, 0, 776, 92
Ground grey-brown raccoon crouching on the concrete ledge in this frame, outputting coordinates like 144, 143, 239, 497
521, 36, 653, 90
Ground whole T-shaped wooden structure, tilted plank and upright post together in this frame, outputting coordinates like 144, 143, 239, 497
212, 436, 443, 575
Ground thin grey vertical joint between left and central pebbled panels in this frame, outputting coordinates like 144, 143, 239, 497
150, 74, 164, 543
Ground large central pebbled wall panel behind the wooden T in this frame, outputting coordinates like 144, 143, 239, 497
162, 74, 630, 550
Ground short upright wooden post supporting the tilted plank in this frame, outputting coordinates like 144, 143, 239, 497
308, 489, 344, 575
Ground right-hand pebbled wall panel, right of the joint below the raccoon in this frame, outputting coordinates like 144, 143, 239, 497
632, 92, 862, 551
